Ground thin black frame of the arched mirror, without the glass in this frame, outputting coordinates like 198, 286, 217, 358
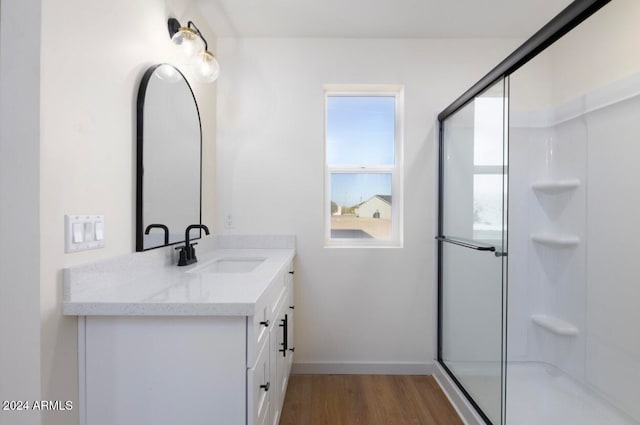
136, 63, 202, 248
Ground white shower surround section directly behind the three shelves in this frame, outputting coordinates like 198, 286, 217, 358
508, 113, 587, 377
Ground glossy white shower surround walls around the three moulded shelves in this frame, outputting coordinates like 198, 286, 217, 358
507, 75, 640, 421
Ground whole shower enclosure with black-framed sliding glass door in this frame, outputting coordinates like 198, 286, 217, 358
437, 0, 640, 425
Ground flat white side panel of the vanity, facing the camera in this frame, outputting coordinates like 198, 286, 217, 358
84, 316, 247, 425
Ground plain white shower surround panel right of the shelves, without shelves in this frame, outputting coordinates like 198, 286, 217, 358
585, 91, 640, 422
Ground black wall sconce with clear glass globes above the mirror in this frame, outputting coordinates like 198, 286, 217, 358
168, 18, 220, 83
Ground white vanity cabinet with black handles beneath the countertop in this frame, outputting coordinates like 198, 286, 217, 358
78, 262, 294, 425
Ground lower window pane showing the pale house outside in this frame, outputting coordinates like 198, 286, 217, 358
330, 173, 392, 240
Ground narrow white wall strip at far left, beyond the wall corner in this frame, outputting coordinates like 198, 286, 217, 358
0, 0, 40, 425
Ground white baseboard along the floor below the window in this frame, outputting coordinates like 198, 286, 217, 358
291, 362, 434, 375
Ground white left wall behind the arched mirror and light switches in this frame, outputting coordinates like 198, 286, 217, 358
36, 0, 215, 425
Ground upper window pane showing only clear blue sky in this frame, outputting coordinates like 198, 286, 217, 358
326, 96, 396, 166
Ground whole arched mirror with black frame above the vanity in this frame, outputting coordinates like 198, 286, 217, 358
136, 64, 202, 251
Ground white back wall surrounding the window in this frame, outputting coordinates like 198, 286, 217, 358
217, 38, 519, 371
